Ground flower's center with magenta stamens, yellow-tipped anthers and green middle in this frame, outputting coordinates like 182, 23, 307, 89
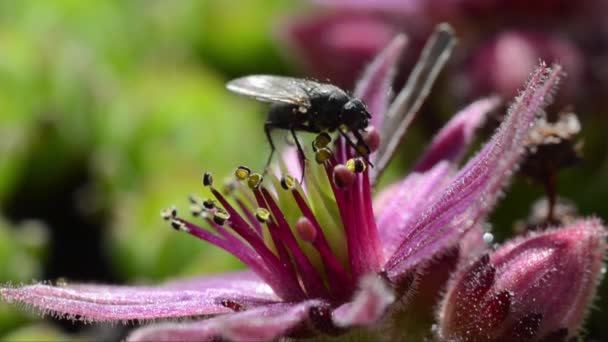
162, 133, 384, 303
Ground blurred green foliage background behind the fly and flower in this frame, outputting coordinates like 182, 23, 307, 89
0, 0, 608, 340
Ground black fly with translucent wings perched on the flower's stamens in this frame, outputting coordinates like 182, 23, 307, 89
226, 75, 371, 176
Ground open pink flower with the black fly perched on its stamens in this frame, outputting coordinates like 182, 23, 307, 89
0, 26, 601, 340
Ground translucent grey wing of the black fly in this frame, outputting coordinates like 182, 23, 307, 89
226, 75, 313, 108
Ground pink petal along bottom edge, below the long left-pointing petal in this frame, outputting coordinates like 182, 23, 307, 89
127, 300, 322, 341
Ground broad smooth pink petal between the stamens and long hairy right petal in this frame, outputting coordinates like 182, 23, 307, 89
374, 162, 454, 256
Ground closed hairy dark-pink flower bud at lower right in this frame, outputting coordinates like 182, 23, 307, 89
438, 220, 606, 341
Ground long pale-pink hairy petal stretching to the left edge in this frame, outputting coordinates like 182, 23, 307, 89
0, 272, 279, 321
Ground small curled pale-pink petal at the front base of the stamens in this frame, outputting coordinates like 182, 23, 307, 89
332, 274, 395, 327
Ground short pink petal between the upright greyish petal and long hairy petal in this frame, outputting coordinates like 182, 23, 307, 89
414, 97, 500, 172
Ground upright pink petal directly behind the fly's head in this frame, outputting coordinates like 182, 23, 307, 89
354, 34, 407, 127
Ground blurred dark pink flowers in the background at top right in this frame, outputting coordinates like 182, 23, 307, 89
280, 0, 608, 104
